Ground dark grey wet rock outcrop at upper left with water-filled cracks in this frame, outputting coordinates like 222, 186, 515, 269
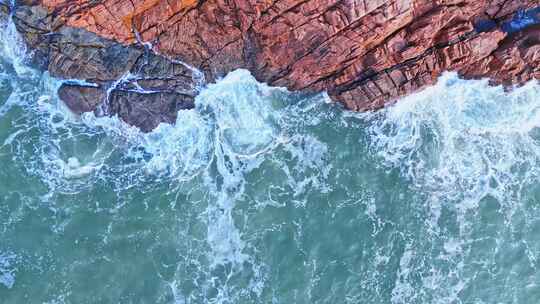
13, 5, 200, 131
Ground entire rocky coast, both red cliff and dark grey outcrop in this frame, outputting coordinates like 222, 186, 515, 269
6, 0, 540, 130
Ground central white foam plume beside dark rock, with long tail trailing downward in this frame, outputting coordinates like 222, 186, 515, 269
76, 70, 282, 303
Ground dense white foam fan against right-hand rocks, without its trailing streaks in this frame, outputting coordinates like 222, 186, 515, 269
370, 73, 540, 209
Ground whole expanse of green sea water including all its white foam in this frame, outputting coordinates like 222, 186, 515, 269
0, 10, 540, 304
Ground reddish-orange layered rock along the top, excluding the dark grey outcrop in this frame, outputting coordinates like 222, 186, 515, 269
10, 0, 540, 128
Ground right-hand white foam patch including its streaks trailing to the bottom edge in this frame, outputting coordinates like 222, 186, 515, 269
365, 73, 540, 303
